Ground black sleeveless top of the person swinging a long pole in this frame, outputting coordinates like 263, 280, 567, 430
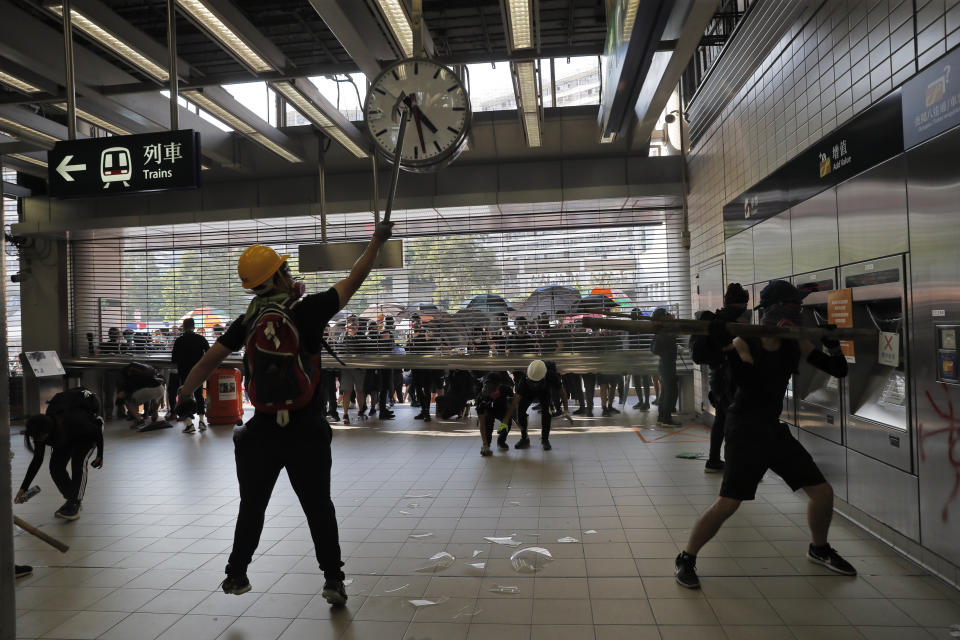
727, 339, 800, 433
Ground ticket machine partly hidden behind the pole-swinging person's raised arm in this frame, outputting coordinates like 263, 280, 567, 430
793, 269, 844, 444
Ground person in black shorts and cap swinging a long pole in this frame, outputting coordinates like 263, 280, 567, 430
675, 281, 857, 589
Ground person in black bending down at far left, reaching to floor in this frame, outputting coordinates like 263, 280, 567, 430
13, 387, 103, 520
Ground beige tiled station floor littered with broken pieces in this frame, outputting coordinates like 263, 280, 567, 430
13, 407, 960, 640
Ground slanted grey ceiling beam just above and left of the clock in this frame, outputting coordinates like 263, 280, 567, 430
310, 0, 396, 78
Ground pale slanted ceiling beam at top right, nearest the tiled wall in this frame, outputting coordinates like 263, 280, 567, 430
633, 0, 718, 145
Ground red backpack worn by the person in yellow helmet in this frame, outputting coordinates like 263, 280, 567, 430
244, 298, 320, 426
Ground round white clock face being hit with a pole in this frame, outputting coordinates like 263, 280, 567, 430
364, 58, 470, 171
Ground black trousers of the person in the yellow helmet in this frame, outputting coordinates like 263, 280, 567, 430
227, 407, 343, 580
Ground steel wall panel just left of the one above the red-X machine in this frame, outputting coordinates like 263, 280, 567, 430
790, 189, 840, 273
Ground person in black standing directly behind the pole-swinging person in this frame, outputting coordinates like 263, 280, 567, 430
690, 282, 750, 473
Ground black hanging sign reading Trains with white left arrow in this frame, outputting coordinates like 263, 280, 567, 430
47, 129, 200, 198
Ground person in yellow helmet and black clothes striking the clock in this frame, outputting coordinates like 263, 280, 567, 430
178, 222, 393, 606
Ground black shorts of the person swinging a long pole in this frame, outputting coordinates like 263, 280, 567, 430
720, 422, 826, 500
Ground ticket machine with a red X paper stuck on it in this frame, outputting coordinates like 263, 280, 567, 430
840, 255, 913, 473
